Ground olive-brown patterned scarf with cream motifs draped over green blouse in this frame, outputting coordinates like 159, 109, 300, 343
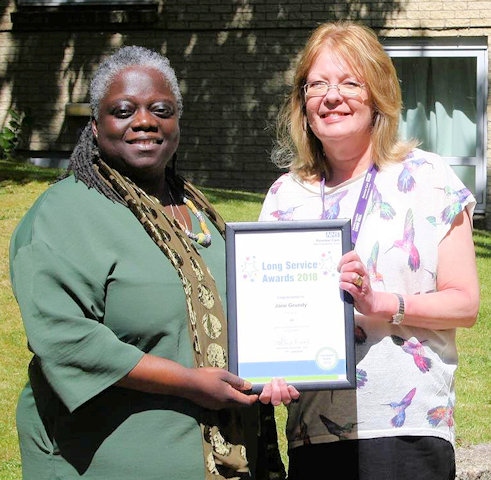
94, 159, 285, 480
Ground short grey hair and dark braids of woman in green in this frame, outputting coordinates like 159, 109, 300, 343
60, 45, 183, 205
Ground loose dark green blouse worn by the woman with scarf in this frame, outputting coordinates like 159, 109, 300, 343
10, 177, 236, 480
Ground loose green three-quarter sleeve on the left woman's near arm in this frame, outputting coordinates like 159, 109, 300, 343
10, 180, 144, 411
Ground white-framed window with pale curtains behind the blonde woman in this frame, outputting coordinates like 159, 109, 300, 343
384, 37, 488, 213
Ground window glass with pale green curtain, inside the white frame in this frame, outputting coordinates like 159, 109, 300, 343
392, 57, 477, 157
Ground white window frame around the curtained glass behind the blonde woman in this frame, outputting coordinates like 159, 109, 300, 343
382, 37, 488, 213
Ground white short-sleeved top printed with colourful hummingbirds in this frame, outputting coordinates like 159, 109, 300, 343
259, 149, 476, 448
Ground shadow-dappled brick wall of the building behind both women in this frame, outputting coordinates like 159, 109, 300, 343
0, 0, 491, 211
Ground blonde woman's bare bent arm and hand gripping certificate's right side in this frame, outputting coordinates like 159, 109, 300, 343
338, 211, 480, 330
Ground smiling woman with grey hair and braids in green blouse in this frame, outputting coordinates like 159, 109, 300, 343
10, 46, 298, 480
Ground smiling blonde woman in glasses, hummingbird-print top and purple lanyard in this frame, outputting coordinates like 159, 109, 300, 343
260, 22, 479, 480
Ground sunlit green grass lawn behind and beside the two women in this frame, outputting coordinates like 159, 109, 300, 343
0, 161, 491, 480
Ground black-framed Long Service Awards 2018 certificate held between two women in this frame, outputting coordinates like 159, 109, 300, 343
225, 219, 356, 392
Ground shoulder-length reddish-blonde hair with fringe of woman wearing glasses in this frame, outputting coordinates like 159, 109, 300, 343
271, 22, 417, 179
